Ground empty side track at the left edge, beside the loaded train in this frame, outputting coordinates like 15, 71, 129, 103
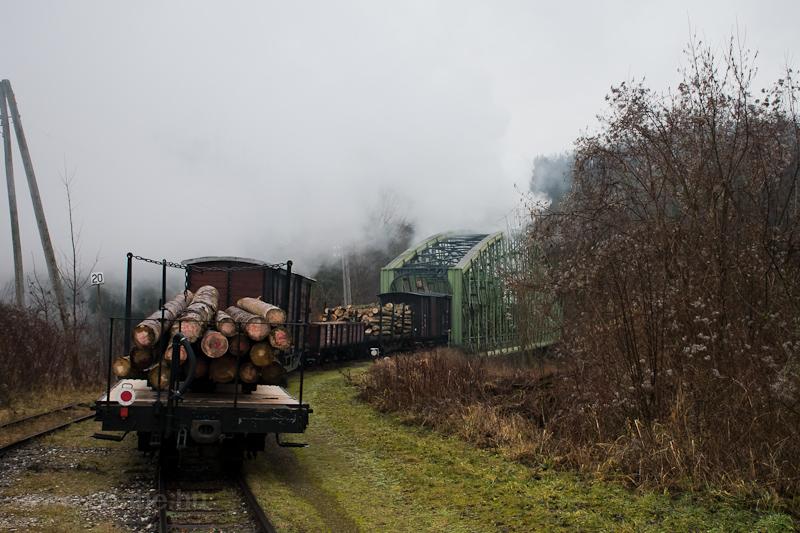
0, 403, 94, 456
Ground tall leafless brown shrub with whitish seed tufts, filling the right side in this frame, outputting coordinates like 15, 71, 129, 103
522, 34, 800, 502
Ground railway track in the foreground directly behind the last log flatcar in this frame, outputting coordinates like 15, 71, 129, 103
155, 448, 275, 533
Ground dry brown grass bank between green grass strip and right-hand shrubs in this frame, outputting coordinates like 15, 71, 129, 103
359, 349, 800, 514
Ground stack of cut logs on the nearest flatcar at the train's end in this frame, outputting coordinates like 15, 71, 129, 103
111, 285, 292, 389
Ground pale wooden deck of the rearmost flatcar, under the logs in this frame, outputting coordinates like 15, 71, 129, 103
98, 379, 300, 408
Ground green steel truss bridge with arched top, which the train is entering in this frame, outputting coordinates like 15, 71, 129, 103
381, 231, 561, 353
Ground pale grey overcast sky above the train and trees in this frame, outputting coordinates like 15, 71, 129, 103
0, 0, 800, 281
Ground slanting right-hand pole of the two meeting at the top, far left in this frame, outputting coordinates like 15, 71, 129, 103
2, 80, 69, 330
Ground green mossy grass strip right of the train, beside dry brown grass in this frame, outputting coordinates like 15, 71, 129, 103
246, 367, 795, 533
